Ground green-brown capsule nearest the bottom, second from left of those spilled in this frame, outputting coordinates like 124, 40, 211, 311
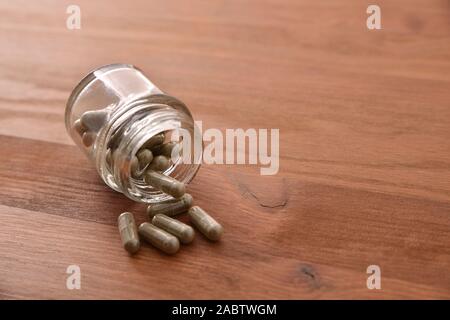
139, 222, 180, 254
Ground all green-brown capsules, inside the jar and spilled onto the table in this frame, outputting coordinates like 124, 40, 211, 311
73, 110, 223, 254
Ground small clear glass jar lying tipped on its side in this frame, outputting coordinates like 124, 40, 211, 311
65, 64, 201, 203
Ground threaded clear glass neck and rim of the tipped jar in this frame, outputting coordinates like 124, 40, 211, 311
95, 97, 200, 203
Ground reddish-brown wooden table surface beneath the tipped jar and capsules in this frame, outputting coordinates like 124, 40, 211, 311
0, 0, 450, 299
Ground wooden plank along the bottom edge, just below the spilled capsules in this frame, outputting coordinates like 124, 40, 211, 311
0, 206, 448, 299
